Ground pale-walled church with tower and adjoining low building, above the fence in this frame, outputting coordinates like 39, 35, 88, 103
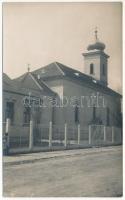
3, 31, 122, 131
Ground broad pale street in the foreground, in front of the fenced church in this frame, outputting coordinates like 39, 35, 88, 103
3, 146, 122, 197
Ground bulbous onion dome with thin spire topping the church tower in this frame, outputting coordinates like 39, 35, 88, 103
87, 29, 106, 51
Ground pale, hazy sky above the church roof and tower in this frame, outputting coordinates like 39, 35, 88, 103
3, 2, 122, 91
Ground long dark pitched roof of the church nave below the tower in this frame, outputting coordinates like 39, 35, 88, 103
33, 62, 122, 97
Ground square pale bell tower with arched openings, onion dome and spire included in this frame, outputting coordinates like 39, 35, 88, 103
82, 28, 109, 86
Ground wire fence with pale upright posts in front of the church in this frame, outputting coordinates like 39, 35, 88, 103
3, 118, 122, 151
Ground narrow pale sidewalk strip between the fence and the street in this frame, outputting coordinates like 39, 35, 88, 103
3, 146, 122, 166
